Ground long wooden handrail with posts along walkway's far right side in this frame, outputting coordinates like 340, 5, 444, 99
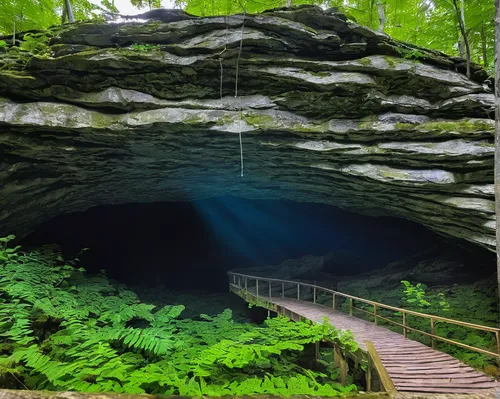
228, 272, 500, 357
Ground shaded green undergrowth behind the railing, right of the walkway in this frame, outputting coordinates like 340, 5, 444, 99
328, 279, 498, 376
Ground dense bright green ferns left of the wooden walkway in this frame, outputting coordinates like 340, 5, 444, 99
0, 237, 356, 396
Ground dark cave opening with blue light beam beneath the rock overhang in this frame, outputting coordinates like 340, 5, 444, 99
21, 196, 494, 293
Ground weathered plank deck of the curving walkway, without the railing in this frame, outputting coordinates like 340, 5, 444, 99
231, 278, 500, 398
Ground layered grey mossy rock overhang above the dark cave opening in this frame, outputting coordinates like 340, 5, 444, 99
0, 6, 495, 250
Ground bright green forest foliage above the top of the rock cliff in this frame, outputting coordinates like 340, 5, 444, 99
0, 0, 495, 72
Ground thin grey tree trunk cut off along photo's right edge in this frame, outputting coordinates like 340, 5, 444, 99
495, 0, 500, 323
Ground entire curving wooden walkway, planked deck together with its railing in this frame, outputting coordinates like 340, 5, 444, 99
229, 273, 500, 398
